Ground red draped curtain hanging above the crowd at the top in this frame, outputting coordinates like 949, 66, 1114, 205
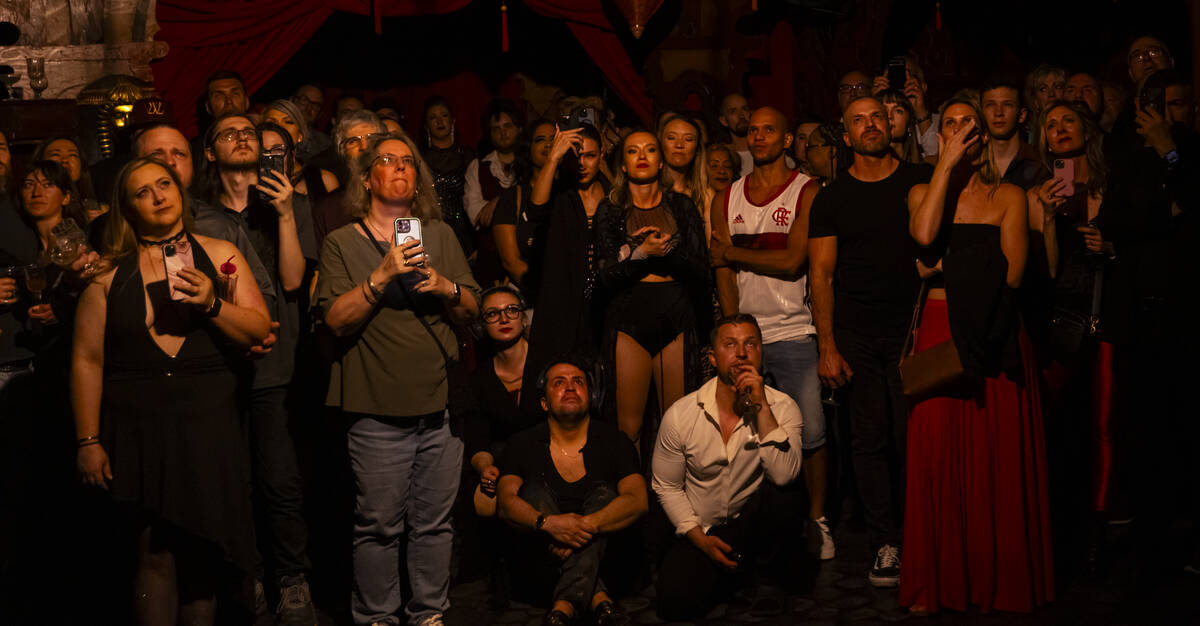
154, 0, 653, 133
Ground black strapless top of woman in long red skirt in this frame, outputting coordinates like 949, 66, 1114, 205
942, 224, 1022, 380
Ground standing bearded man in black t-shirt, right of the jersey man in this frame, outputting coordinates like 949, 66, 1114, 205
809, 97, 930, 586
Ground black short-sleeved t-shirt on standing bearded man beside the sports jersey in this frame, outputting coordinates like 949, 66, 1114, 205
809, 161, 931, 337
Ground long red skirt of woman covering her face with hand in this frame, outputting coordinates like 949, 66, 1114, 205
900, 300, 1054, 613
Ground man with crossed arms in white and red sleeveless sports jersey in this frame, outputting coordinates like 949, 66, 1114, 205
709, 107, 835, 560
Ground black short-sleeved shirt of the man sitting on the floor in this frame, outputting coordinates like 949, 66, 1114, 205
497, 420, 641, 513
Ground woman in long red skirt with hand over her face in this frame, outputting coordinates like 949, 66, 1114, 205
900, 100, 1054, 613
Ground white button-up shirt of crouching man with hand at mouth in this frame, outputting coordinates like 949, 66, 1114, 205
650, 378, 803, 535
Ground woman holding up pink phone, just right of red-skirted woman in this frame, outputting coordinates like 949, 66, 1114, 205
1027, 101, 1132, 573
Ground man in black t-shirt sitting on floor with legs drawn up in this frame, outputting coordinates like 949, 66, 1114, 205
497, 359, 647, 625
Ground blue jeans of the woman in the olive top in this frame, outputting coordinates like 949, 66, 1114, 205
347, 411, 463, 624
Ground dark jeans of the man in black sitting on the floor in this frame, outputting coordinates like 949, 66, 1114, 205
517, 481, 617, 612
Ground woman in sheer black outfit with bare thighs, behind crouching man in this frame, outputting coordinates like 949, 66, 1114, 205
596, 130, 712, 446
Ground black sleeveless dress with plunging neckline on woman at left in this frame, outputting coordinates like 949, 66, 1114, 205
100, 235, 254, 606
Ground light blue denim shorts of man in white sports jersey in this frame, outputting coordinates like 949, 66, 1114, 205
762, 335, 824, 450
